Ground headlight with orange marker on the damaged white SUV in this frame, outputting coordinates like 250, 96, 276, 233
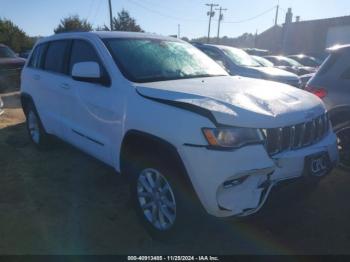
203, 127, 264, 149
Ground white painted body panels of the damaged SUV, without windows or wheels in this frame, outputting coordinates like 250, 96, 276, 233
21, 33, 338, 217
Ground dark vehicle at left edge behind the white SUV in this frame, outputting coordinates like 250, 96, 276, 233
0, 44, 25, 92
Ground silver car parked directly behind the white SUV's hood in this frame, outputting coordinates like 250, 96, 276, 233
195, 44, 301, 88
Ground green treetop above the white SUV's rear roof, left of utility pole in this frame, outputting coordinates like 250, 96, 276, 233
54, 15, 92, 34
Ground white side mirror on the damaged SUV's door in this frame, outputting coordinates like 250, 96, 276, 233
72, 62, 103, 84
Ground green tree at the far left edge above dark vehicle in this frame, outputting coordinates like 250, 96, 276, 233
0, 19, 35, 52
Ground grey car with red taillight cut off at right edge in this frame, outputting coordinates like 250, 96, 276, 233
306, 45, 350, 170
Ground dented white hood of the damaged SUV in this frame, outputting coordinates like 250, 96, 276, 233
135, 76, 325, 128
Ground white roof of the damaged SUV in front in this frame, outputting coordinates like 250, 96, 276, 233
39, 31, 182, 42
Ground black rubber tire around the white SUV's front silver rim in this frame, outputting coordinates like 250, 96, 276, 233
128, 155, 203, 242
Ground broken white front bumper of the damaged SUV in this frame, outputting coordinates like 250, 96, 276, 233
179, 132, 338, 217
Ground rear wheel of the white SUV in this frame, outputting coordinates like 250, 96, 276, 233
24, 103, 50, 150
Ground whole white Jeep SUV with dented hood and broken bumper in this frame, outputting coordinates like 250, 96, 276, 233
21, 32, 338, 237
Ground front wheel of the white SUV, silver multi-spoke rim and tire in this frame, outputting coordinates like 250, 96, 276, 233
129, 156, 198, 241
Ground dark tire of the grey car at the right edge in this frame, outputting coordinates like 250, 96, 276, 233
333, 121, 350, 171
